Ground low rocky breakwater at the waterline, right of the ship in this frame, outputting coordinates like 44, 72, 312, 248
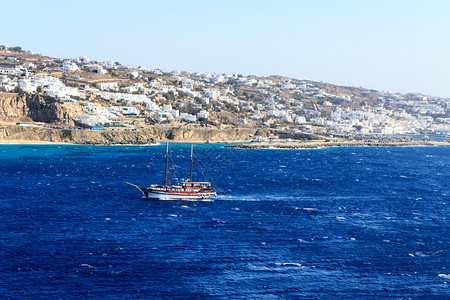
226, 141, 435, 149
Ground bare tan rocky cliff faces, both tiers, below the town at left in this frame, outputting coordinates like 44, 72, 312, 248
0, 93, 260, 145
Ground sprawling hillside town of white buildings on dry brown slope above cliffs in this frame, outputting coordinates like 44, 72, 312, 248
0, 45, 450, 138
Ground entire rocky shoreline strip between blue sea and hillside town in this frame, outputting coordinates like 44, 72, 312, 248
0, 125, 449, 149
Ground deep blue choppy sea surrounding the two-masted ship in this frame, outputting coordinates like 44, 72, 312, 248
0, 144, 450, 299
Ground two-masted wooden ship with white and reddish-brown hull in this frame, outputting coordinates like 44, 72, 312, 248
126, 143, 217, 201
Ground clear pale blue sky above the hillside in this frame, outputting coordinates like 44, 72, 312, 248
0, 0, 450, 97
